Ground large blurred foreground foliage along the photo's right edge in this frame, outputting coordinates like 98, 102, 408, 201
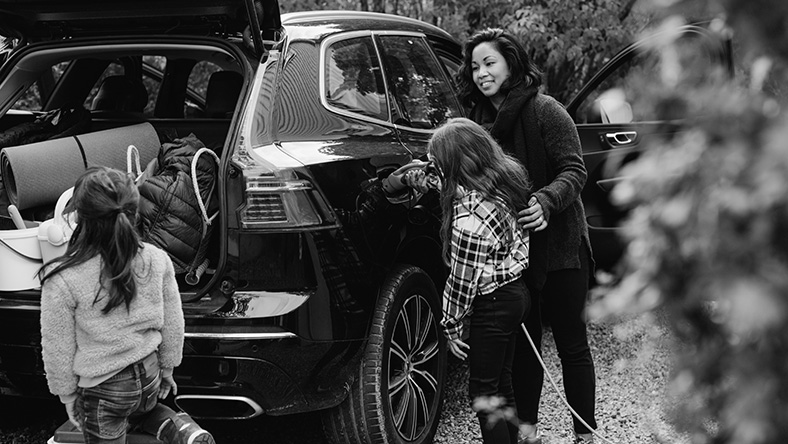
592, 0, 788, 444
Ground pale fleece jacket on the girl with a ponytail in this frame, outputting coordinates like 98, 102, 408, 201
41, 244, 184, 402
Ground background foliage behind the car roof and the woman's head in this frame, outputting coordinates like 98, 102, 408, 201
282, 0, 649, 103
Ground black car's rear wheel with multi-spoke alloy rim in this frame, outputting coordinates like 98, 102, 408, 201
323, 266, 447, 444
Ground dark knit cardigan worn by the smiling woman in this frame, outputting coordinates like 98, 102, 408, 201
470, 84, 593, 289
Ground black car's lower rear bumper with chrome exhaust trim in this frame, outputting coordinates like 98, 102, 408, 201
175, 332, 365, 419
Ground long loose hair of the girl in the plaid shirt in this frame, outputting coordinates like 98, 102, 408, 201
427, 117, 531, 263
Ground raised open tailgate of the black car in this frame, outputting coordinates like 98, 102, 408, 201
0, 0, 280, 40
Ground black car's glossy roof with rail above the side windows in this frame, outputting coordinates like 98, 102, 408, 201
282, 11, 456, 41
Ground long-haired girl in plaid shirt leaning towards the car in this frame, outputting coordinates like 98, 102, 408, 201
428, 118, 530, 444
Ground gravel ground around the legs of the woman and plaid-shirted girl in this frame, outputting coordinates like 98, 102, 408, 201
435, 310, 688, 444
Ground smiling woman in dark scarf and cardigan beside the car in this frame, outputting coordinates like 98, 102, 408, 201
458, 29, 596, 443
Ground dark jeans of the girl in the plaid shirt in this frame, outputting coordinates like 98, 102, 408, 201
468, 278, 530, 444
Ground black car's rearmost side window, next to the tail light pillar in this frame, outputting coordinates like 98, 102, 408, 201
324, 37, 388, 120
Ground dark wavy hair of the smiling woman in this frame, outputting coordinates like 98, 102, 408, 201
456, 28, 542, 107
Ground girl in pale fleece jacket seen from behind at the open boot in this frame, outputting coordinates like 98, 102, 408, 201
40, 167, 214, 444
